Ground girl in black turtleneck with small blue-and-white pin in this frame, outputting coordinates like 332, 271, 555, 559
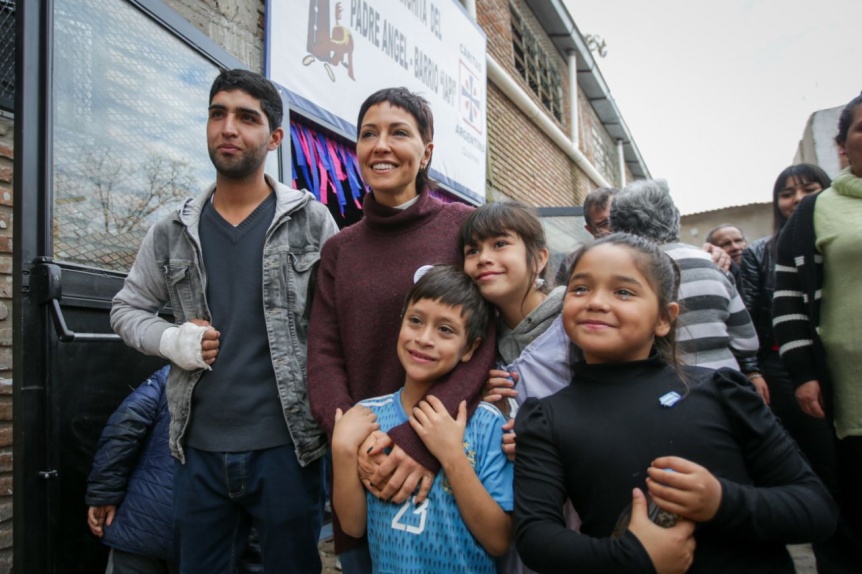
515, 234, 836, 574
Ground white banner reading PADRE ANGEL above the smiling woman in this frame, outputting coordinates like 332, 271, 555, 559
265, 0, 487, 204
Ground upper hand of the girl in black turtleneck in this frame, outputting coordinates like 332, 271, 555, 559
647, 456, 721, 522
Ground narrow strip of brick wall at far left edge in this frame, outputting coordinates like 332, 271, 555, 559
0, 117, 15, 574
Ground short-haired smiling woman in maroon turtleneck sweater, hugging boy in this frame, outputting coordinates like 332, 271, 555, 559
308, 88, 495, 572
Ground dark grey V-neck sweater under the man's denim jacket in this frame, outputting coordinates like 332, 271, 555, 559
186, 194, 291, 452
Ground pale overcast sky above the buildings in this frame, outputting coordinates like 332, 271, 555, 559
564, 0, 862, 214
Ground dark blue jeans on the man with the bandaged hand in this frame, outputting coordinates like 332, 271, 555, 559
174, 445, 323, 574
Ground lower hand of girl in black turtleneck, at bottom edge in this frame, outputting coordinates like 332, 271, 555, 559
629, 488, 695, 574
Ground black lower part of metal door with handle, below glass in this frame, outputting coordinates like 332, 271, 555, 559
30, 258, 169, 573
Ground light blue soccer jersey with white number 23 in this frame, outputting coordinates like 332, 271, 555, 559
360, 390, 513, 574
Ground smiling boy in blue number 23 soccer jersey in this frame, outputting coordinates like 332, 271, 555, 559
332, 265, 513, 574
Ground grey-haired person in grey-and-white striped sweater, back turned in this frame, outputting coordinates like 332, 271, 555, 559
611, 179, 769, 402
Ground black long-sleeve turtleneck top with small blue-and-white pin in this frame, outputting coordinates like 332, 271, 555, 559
515, 355, 836, 574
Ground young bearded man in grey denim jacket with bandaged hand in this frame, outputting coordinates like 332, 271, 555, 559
111, 70, 337, 574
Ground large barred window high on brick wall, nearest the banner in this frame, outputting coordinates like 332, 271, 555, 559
509, 4, 563, 122
